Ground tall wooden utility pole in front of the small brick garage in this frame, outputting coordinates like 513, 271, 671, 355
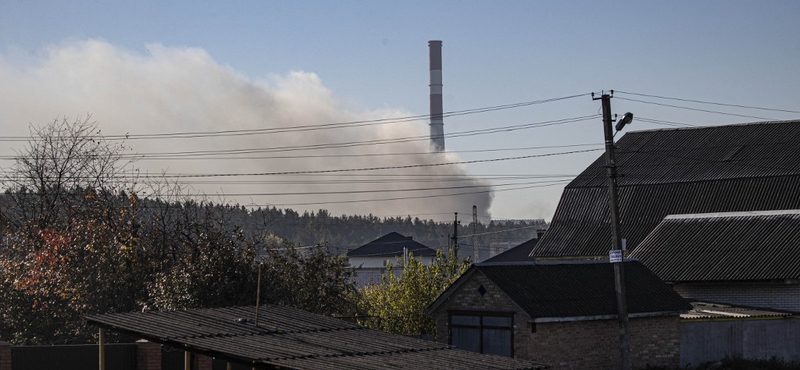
592, 90, 631, 370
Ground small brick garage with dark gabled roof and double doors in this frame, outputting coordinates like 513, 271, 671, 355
427, 261, 691, 369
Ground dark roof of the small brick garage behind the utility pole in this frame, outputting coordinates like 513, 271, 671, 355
428, 260, 692, 321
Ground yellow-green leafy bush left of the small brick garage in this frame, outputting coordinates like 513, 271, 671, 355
361, 251, 470, 335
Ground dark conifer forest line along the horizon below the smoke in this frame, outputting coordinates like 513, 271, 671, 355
0, 192, 547, 253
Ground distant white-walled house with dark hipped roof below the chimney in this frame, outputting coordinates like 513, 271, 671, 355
347, 232, 436, 286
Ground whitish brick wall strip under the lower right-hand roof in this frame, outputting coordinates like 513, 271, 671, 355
673, 283, 800, 312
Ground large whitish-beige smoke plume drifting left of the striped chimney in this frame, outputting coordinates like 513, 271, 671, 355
0, 40, 492, 218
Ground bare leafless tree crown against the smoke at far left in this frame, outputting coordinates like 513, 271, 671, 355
3, 116, 135, 228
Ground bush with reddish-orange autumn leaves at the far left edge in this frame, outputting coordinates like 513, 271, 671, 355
0, 197, 151, 344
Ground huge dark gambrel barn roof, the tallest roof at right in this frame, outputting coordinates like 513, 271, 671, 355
532, 121, 800, 257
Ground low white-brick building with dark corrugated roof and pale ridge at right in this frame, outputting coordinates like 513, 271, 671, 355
631, 210, 800, 312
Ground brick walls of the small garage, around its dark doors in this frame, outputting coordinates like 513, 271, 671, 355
434, 273, 680, 370
